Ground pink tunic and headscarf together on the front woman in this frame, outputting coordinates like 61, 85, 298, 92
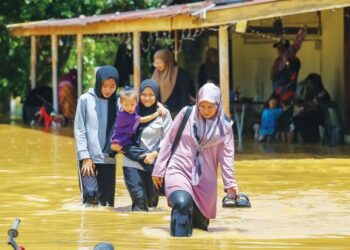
152, 84, 237, 218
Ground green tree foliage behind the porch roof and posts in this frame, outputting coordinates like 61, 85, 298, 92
0, 0, 164, 112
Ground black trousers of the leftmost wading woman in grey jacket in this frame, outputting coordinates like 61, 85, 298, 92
79, 161, 116, 207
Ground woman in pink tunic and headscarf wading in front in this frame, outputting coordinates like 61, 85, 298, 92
152, 83, 238, 236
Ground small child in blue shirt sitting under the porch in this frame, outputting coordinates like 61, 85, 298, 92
254, 97, 283, 142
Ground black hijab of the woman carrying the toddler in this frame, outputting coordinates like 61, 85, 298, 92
139, 79, 159, 130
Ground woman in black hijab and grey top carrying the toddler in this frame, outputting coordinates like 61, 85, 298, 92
119, 79, 172, 211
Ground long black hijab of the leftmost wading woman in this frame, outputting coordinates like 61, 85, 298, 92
94, 65, 119, 141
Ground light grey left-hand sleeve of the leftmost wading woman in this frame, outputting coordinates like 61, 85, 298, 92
74, 96, 90, 160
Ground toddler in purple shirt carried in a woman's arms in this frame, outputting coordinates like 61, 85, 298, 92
111, 88, 163, 171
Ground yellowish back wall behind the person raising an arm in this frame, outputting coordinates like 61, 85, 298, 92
232, 34, 321, 101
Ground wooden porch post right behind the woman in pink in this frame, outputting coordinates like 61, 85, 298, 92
219, 26, 230, 116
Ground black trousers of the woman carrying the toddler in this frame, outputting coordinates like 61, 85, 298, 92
123, 167, 159, 211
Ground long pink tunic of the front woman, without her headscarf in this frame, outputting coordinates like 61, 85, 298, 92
152, 108, 237, 219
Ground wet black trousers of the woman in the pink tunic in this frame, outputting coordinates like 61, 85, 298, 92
169, 191, 209, 237
